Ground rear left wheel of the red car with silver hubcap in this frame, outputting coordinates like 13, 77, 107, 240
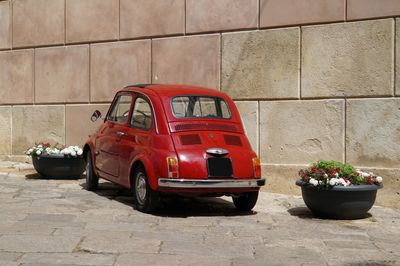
133, 167, 160, 213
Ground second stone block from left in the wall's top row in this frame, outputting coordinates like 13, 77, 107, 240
12, 0, 65, 47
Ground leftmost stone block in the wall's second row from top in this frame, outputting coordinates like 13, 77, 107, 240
0, 50, 34, 104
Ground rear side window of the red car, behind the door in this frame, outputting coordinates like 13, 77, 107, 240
131, 97, 153, 130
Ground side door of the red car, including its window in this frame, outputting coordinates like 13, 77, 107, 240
95, 92, 132, 179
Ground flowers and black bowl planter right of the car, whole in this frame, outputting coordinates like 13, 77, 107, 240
296, 160, 383, 219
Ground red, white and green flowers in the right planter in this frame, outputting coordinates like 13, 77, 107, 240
299, 160, 383, 187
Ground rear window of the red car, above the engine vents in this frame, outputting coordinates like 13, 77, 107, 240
171, 96, 231, 119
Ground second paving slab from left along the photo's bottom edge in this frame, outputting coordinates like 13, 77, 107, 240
20, 253, 115, 266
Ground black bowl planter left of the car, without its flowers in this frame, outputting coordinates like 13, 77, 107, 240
32, 154, 86, 179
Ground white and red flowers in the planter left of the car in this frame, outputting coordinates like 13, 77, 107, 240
25, 142, 83, 157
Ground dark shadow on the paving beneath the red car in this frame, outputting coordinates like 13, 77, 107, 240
80, 182, 257, 218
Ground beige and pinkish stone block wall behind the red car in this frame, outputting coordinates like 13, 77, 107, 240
0, 0, 400, 207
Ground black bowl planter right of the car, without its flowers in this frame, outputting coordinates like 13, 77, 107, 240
296, 180, 383, 220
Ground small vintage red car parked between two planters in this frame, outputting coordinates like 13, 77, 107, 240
84, 84, 265, 212
